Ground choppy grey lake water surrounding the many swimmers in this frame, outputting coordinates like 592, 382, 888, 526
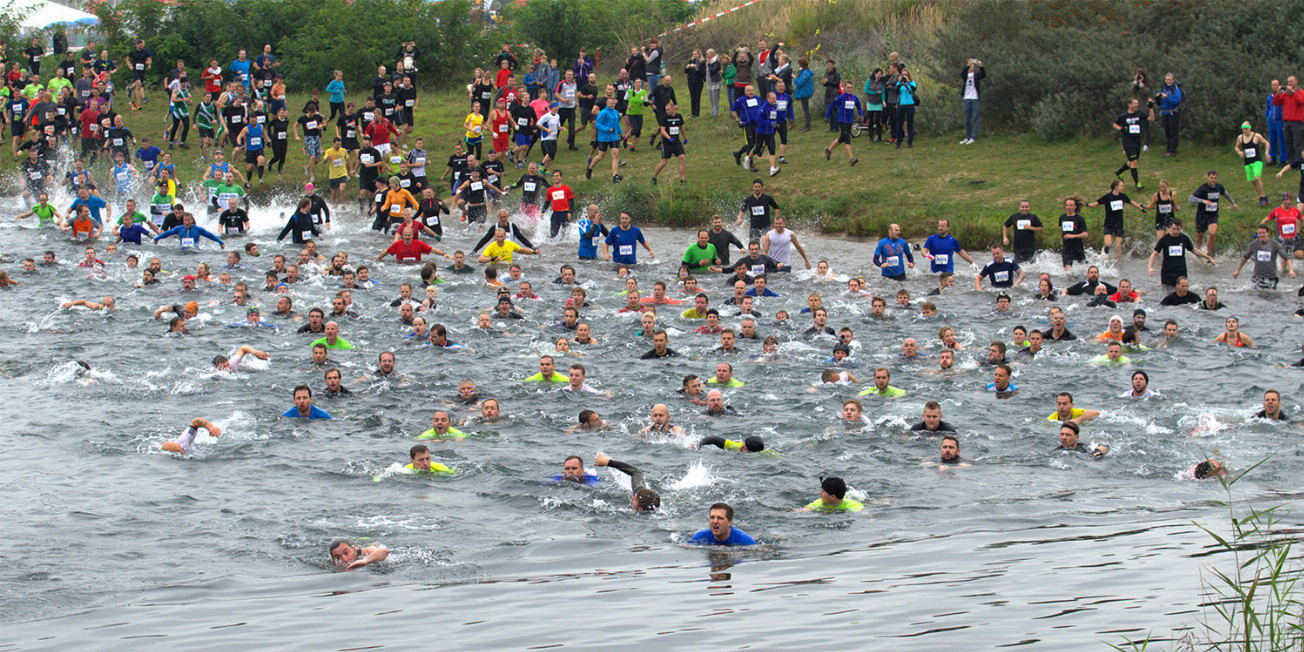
0, 182, 1304, 649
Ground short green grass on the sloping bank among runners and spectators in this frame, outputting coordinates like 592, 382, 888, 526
0, 84, 1297, 249
